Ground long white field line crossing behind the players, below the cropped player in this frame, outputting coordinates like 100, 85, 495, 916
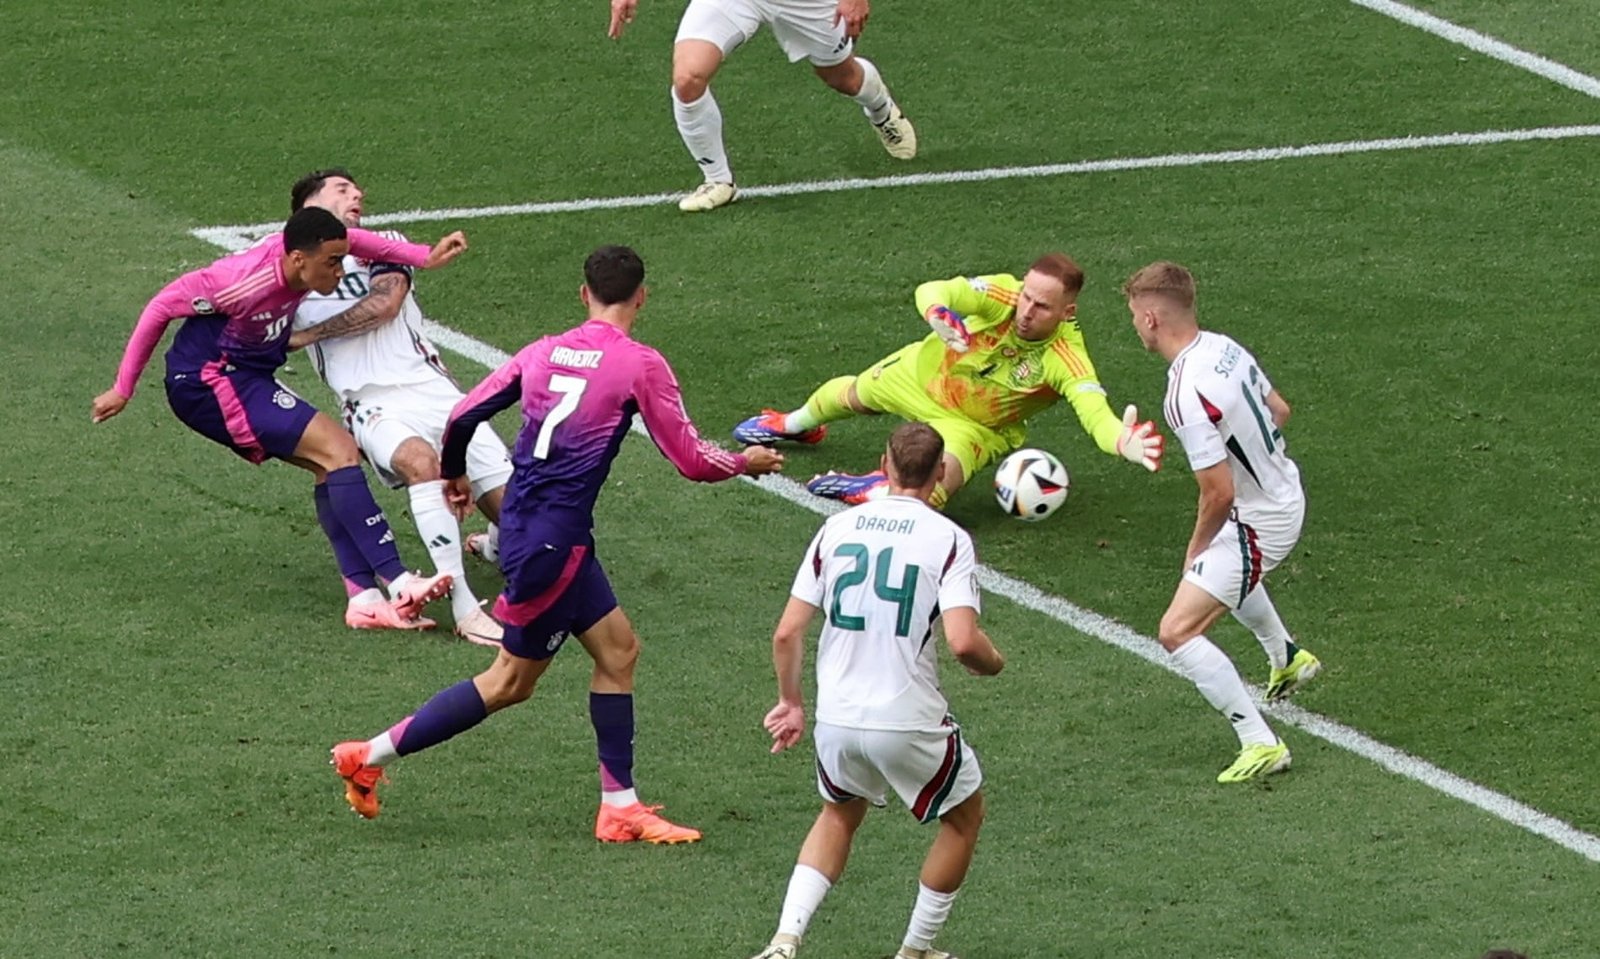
192, 124, 1600, 250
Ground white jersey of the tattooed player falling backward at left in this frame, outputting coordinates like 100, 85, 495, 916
294, 232, 454, 400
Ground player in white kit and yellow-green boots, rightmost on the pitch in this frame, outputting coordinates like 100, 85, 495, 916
1123, 263, 1322, 783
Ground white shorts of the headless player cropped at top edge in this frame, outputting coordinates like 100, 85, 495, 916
675, 0, 854, 67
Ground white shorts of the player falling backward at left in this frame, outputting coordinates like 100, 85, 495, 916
344, 378, 512, 500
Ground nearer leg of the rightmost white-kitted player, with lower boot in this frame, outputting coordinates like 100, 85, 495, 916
1157, 541, 1290, 783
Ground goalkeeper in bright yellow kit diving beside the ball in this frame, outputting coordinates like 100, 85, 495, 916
733, 253, 1162, 509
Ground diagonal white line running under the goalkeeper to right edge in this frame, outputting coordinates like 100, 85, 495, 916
403, 320, 1600, 863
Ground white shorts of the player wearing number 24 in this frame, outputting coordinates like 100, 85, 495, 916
813, 720, 984, 823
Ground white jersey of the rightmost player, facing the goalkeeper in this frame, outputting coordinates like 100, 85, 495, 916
1165, 330, 1306, 530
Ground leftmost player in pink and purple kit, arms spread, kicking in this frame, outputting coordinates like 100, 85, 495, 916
93, 208, 467, 629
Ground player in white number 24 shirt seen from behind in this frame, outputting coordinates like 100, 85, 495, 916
757, 423, 1005, 959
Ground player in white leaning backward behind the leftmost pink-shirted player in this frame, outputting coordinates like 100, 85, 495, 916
290, 168, 510, 645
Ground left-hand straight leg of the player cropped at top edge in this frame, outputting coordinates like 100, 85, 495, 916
672, 0, 762, 213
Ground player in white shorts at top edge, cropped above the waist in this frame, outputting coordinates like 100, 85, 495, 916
608, 0, 917, 213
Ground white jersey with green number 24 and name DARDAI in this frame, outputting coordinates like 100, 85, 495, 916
790, 496, 979, 730
